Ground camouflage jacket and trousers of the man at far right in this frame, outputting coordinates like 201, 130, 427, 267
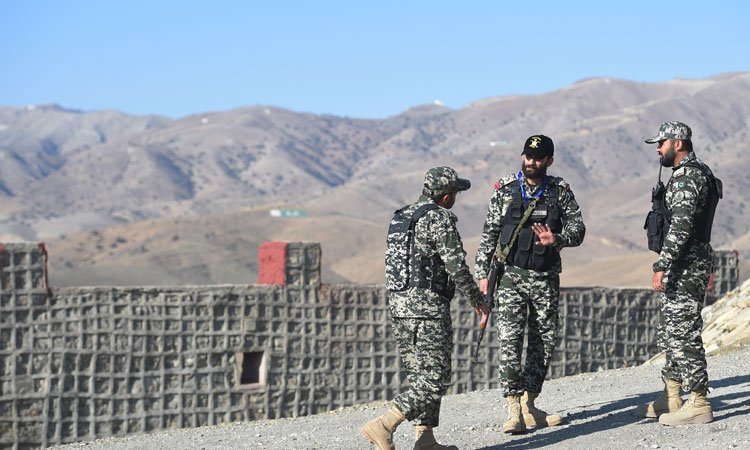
653, 152, 713, 391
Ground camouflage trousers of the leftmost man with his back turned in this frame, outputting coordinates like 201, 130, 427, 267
391, 316, 453, 427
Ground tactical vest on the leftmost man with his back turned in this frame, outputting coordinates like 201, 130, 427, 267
385, 203, 456, 299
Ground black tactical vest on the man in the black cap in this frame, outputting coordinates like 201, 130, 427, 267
500, 181, 562, 272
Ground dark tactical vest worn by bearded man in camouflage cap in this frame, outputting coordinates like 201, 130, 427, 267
643, 161, 724, 253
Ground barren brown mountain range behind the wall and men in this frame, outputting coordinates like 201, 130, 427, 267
0, 73, 750, 286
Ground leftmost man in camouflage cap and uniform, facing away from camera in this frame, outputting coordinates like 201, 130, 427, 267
362, 167, 487, 450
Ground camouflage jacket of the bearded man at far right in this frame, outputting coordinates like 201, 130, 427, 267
653, 152, 712, 272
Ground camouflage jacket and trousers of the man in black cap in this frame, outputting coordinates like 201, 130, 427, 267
475, 174, 586, 396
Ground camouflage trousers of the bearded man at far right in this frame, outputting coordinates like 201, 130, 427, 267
657, 258, 712, 392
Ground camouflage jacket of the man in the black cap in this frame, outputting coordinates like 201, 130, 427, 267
474, 173, 586, 280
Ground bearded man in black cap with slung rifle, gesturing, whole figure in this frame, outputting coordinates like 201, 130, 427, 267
475, 135, 586, 433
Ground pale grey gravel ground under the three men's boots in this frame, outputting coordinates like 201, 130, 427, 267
55, 347, 750, 450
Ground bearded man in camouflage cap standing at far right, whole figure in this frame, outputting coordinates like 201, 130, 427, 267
637, 122, 722, 425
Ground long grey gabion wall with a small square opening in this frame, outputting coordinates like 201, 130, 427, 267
0, 244, 740, 449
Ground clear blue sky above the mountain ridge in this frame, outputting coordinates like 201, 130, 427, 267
0, 0, 750, 118
